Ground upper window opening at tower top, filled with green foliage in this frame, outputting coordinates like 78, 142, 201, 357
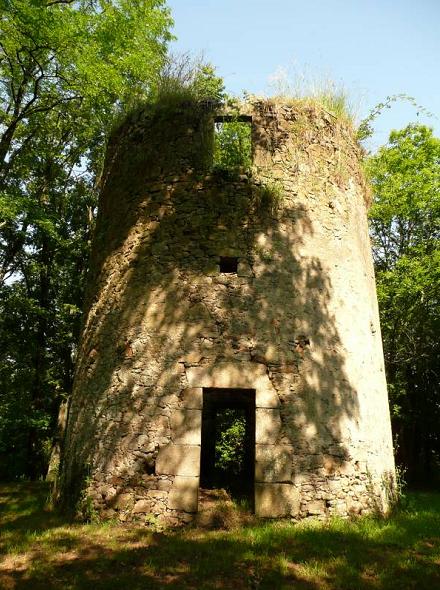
214, 115, 252, 170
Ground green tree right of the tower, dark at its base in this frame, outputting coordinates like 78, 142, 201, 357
367, 125, 440, 482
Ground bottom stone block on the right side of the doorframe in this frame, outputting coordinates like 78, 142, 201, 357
255, 483, 300, 518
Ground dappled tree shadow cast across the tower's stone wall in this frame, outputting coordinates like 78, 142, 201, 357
61, 104, 359, 506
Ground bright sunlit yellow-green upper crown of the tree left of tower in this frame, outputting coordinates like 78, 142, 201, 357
0, 0, 171, 278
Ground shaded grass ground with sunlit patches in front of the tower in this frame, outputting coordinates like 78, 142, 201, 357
0, 483, 440, 590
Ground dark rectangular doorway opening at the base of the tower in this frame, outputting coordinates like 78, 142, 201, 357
200, 388, 255, 510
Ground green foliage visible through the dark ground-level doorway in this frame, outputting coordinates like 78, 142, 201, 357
215, 409, 246, 475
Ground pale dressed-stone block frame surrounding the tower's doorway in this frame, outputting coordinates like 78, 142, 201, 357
156, 362, 299, 518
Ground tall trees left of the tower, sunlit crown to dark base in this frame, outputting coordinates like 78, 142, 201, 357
0, 0, 172, 477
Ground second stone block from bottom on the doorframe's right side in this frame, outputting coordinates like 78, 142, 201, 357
255, 445, 293, 482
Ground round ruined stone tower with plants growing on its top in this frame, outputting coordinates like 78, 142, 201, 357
61, 101, 394, 524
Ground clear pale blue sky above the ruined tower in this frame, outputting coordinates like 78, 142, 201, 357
168, 0, 440, 149
